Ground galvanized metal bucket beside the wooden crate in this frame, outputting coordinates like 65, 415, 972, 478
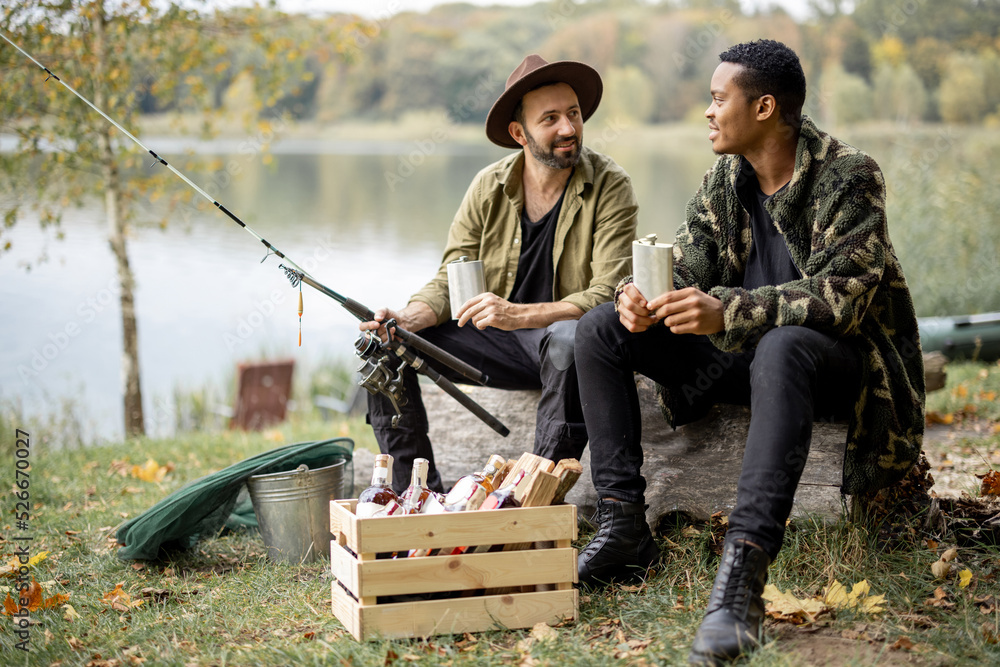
247, 460, 345, 563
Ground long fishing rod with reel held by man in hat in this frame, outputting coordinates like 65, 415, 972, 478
0, 32, 510, 437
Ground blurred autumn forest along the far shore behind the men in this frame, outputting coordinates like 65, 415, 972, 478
143, 0, 1000, 125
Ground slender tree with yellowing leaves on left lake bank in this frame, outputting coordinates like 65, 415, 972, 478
0, 0, 328, 437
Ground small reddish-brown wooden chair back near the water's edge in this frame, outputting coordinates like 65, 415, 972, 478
229, 359, 295, 431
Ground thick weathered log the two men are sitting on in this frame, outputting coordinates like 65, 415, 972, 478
355, 376, 847, 530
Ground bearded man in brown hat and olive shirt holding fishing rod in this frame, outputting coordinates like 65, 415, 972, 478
360, 55, 638, 491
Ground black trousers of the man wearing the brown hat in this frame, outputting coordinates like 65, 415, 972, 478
368, 320, 587, 493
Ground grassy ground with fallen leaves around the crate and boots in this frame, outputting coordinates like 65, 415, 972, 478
0, 364, 1000, 667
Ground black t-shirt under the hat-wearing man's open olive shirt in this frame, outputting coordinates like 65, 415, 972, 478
510, 180, 569, 303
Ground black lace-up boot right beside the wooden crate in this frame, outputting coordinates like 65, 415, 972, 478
577, 499, 660, 587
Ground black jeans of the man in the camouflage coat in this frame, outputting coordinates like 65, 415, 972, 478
576, 303, 861, 559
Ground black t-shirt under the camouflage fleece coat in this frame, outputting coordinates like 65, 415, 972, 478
736, 160, 802, 289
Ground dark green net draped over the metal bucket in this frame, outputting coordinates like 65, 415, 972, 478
117, 438, 354, 560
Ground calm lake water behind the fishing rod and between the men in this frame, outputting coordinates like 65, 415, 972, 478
0, 132, 713, 439
